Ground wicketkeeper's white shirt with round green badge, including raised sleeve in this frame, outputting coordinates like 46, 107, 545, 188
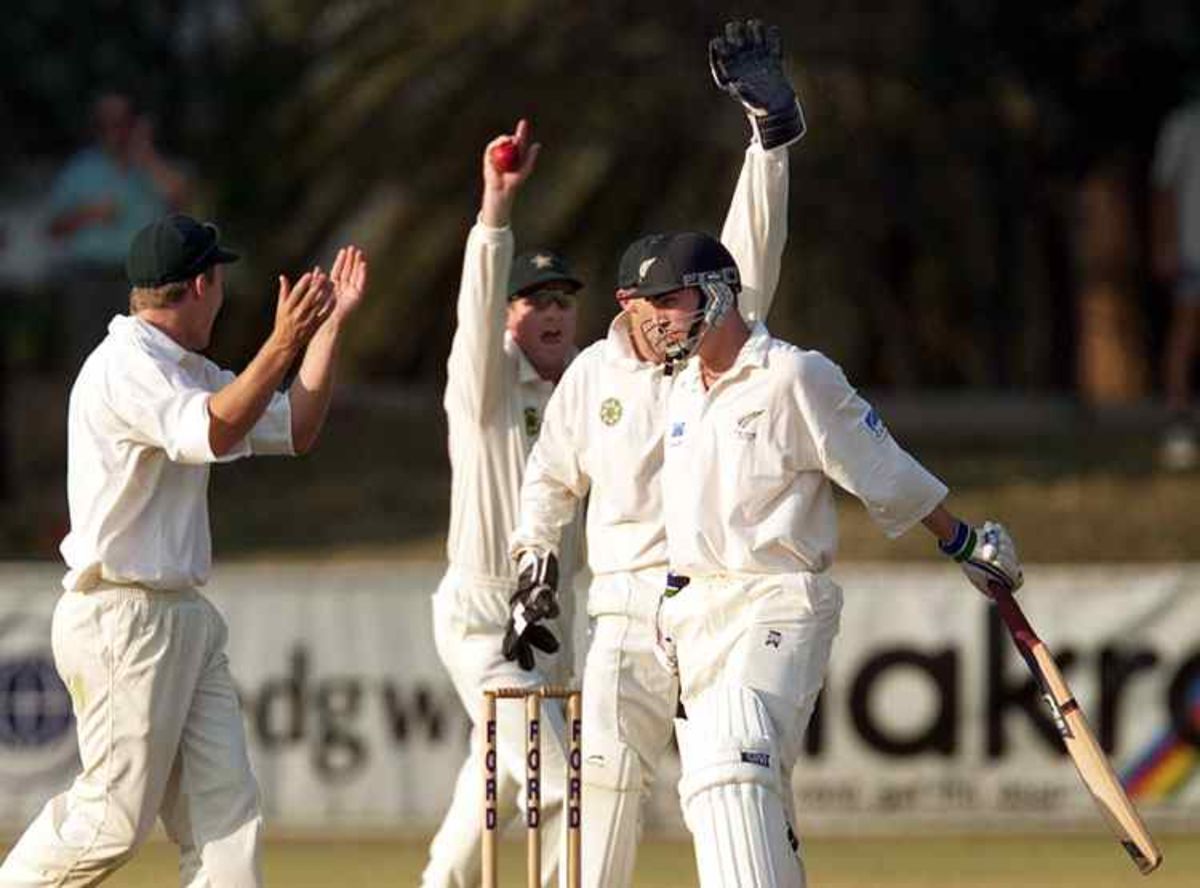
512, 144, 788, 575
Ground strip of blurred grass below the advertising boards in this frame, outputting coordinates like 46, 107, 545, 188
7, 833, 1200, 888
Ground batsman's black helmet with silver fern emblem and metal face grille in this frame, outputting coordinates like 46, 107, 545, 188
636, 232, 742, 374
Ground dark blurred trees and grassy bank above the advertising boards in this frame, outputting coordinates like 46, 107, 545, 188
7, 0, 1200, 562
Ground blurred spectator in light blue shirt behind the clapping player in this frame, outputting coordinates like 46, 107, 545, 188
48, 92, 188, 373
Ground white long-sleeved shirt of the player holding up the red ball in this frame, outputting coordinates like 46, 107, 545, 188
444, 222, 577, 587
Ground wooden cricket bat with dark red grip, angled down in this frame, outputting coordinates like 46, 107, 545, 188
989, 583, 1163, 875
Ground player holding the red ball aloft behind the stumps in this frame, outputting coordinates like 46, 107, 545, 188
421, 121, 581, 888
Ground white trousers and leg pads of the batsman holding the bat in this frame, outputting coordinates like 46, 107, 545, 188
659, 574, 842, 888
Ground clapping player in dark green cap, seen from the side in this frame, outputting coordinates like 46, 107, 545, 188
0, 216, 366, 888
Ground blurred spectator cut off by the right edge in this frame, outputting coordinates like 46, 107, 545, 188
1151, 98, 1200, 470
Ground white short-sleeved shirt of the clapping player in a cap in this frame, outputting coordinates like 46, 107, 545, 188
60, 316, 293, 590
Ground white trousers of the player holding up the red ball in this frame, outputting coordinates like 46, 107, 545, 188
421, 568, 571, 888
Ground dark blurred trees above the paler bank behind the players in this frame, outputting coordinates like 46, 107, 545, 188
0, 0, 1200, 390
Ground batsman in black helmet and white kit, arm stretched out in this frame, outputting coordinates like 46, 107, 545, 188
637, 233, 1021, 888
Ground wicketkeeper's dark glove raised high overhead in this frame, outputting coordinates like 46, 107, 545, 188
708, 18, 806, 149
